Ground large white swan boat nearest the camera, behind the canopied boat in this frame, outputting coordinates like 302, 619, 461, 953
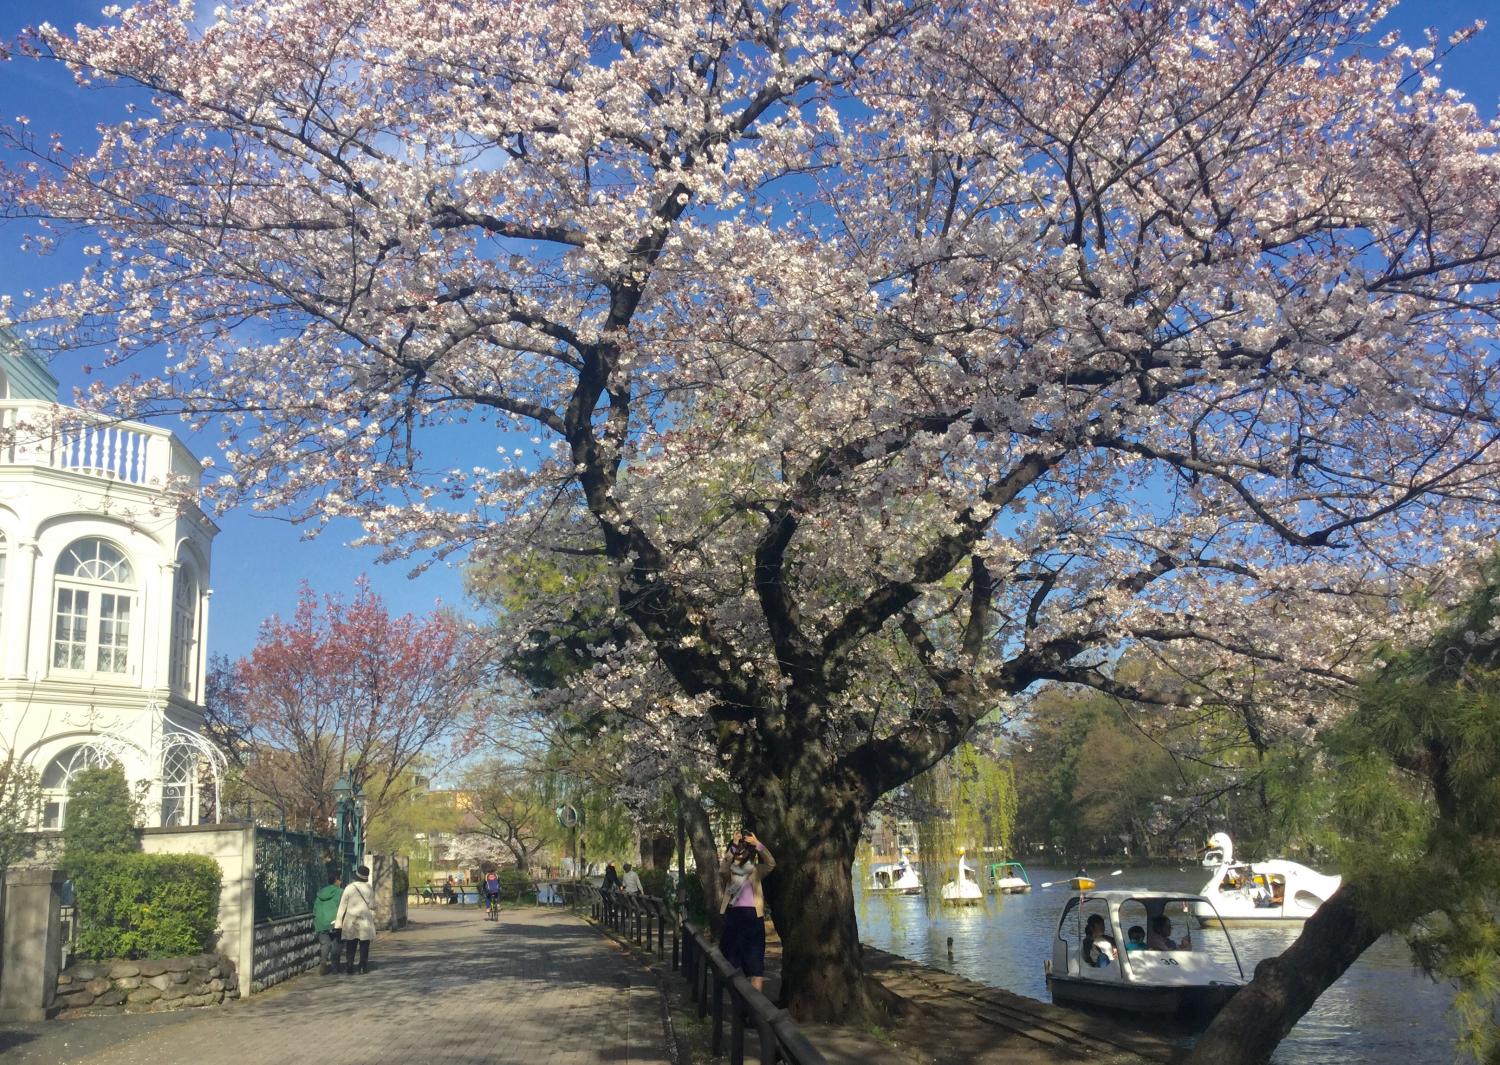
1197, 833, 1343, 927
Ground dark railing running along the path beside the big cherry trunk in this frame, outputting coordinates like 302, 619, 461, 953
564, 884, 827, 1065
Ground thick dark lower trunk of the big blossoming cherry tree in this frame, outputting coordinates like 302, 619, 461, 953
756, 792, 873, 1025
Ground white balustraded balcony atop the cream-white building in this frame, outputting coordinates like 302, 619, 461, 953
0, 399, 203, 491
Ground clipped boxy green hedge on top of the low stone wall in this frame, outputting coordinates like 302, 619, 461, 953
74, 854, 221, 959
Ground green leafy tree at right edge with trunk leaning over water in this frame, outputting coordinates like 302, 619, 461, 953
1188, 558, 1500, 1065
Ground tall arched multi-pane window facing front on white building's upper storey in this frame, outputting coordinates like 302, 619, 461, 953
53, 537, 135, 674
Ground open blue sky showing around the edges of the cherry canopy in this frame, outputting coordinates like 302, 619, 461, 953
0, 0, 1500, 657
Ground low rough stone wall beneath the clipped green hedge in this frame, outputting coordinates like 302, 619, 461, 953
50, 954, 240, 1017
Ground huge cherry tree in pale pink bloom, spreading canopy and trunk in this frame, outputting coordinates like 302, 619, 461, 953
0, 0, 1500, 1019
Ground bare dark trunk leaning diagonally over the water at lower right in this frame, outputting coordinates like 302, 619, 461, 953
1184, 884, 1380, 1065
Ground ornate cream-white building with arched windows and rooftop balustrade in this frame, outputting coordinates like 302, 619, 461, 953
0, 330, 222, 830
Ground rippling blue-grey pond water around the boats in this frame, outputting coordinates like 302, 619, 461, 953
855, 866, 1454, 1065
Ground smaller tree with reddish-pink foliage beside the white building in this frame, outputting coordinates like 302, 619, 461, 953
229, 581, 488, 828
